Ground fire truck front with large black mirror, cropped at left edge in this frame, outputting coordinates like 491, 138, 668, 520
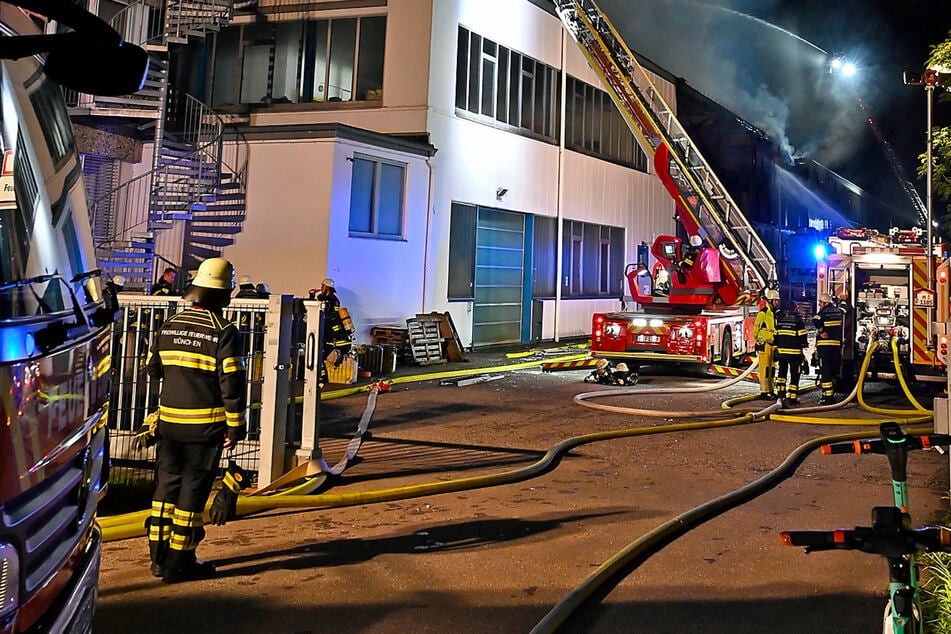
0, 0, 147, 634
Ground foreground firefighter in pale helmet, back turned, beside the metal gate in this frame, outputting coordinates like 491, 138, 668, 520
146, 258, 247, 583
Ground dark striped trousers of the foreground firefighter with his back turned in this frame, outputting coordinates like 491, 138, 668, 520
149, 437, 221, 551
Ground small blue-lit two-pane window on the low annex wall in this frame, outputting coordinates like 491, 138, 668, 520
350, 156, 406, 238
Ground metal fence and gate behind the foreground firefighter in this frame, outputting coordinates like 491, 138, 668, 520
109, 293, 323, 485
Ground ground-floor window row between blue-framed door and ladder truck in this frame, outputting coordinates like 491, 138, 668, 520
561, 220, 624, 297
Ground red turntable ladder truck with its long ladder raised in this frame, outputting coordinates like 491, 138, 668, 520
555, 0, 777, 365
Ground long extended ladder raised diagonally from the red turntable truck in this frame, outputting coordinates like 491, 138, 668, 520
555, 0, 776, 291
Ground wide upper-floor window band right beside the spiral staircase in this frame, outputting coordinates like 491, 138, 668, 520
212, 16, 386, 107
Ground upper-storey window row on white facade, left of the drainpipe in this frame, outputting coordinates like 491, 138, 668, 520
456, 27, 560, 141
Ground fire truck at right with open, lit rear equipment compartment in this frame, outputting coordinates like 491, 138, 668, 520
816, 228, 949, 386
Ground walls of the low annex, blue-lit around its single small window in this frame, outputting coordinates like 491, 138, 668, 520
223, 138, 429, 341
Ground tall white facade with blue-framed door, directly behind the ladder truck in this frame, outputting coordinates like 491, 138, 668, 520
426, 0, 675, 344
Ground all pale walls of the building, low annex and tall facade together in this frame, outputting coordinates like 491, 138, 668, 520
207, 0, 674, 345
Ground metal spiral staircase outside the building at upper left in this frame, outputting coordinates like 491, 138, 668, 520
76, 0, 247, 289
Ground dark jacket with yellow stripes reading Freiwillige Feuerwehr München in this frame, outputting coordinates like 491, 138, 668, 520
148, 306, 247, 442
